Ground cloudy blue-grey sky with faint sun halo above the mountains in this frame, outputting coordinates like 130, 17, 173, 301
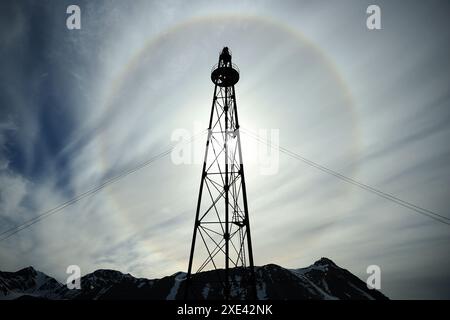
0, 0, 450, 299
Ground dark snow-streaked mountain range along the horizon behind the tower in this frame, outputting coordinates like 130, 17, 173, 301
0, 258, 387, 300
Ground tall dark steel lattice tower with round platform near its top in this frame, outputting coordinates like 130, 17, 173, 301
185, 47, 256, 299
